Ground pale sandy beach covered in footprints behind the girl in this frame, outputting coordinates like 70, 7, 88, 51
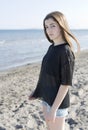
0, 50, 88, 130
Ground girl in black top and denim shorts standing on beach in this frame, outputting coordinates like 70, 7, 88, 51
29, 11, 80, 130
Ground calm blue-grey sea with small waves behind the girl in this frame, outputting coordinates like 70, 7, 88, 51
0, 29, 88, 71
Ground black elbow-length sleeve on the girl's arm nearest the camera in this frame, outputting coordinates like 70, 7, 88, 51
60, 52, 74, 86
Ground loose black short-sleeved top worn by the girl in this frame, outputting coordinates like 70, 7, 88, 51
33, 43, 75, 108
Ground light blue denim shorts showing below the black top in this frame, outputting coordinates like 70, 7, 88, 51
42, 101, 68, 117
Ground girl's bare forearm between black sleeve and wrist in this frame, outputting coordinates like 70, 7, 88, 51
51, 85, 69, 111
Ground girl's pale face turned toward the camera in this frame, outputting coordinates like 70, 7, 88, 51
45, 18, 62, 42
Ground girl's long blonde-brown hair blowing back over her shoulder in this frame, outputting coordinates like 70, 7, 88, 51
43, 11, 80, 53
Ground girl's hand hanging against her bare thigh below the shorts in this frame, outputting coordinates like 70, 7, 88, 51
45, 109, 56, 122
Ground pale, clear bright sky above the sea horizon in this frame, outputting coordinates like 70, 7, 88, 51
0, 0, 88, 29
